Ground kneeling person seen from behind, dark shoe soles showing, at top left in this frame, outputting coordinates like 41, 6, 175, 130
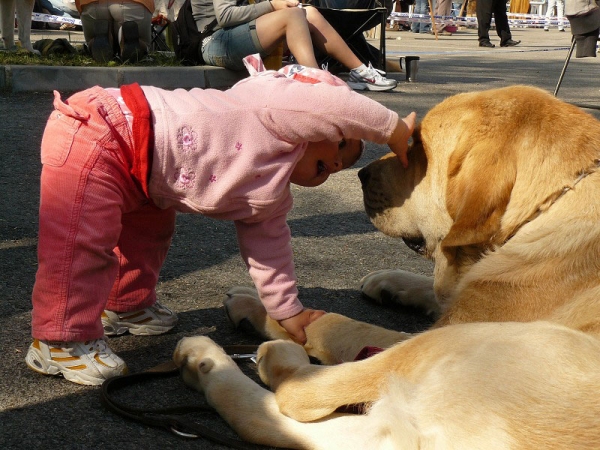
75, 0, 154, 62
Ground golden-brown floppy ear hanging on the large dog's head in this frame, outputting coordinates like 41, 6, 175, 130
441, 141, 516, 265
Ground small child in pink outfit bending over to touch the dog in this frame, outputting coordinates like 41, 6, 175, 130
26, 61, 414, 384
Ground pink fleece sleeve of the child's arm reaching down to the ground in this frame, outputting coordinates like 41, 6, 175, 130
235, 195, 303, 320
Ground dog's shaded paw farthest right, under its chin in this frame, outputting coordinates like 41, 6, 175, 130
361, 270, 440, 316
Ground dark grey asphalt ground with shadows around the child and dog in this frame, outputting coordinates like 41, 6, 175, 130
0, 22, 600, 450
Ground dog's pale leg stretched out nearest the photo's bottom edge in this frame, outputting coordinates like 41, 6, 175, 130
173, 336, 414, 450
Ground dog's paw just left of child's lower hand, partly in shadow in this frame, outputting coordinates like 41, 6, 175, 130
223, 286, 289, 339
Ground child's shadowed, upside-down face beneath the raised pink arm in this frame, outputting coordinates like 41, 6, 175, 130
290, 139, 363, 187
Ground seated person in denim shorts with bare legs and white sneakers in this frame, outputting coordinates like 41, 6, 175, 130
192, 0, 397, 91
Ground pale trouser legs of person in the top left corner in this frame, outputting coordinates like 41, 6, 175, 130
0, 0, 35, 52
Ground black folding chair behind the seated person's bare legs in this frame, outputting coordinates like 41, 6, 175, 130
310, 0, 389, 71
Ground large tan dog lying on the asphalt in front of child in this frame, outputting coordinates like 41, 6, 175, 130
174, 86, 600, 450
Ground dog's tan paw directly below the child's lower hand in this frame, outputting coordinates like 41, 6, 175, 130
257, 340, 310, 391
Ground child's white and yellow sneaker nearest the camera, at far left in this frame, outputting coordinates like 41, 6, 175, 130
25, 338, 127, 386
